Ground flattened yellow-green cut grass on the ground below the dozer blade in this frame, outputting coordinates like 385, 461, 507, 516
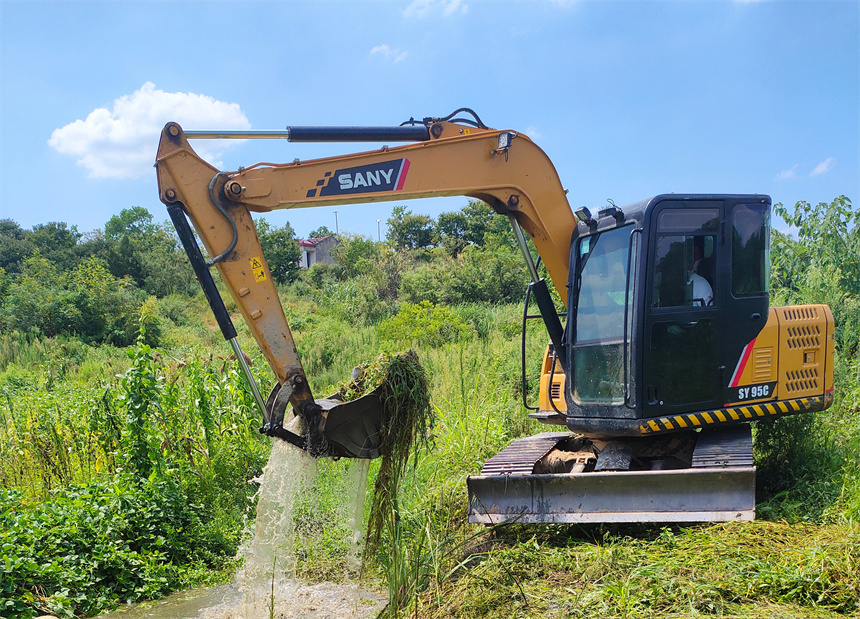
418, 521, 860, 619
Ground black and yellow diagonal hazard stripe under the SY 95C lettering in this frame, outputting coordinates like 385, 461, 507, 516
639, 394, 833, 434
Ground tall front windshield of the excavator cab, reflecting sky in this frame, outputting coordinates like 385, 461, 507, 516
573, 226, 632, 404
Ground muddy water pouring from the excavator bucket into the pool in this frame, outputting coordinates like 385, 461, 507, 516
200, 440, 385, 619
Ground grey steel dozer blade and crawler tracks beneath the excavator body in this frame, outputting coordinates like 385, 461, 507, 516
466, 424, 755, 524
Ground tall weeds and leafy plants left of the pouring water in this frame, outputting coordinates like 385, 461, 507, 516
0, 322, 269, 618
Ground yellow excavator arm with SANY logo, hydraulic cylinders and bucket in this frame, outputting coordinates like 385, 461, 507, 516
155, 111, 576, 457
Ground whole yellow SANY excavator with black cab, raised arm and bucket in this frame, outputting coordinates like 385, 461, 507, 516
155, 108, 834, 524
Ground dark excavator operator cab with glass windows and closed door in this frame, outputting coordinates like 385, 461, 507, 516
565, 199, 770, 435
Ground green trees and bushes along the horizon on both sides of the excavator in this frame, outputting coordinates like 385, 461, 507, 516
0, 196, 860, 357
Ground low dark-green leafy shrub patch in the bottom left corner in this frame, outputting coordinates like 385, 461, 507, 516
0, 475, 225, 619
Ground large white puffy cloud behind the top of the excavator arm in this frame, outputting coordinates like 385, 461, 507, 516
48, 82, 251, 178
